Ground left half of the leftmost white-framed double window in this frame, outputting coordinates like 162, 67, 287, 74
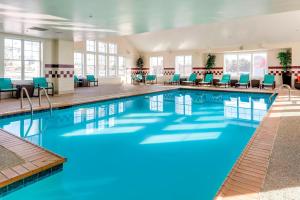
4, 39, 22, 80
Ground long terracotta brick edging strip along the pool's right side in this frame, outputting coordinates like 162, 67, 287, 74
215, 94, 280, 200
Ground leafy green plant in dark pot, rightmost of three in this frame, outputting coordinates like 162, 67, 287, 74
277, 50, 292, 86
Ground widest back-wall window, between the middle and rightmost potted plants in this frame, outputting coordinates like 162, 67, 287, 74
224, 52, 268, 78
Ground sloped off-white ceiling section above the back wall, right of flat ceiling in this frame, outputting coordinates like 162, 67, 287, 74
126, 11, 300, 52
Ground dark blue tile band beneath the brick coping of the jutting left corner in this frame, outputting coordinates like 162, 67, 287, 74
0, 164, 63, 197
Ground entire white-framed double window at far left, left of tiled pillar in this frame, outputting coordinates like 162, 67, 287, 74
4, 38, 42, 80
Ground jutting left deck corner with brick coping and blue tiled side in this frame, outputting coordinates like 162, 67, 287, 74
0, 130, 65, 197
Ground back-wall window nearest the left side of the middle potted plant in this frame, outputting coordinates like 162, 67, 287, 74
175, 56, 192, 76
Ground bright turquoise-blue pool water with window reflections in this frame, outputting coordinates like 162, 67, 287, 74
0, 90, 270, 200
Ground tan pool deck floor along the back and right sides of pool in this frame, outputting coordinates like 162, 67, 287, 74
0, 85, 300, 200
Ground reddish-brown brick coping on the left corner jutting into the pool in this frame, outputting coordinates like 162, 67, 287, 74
0, 129, 65, 188
